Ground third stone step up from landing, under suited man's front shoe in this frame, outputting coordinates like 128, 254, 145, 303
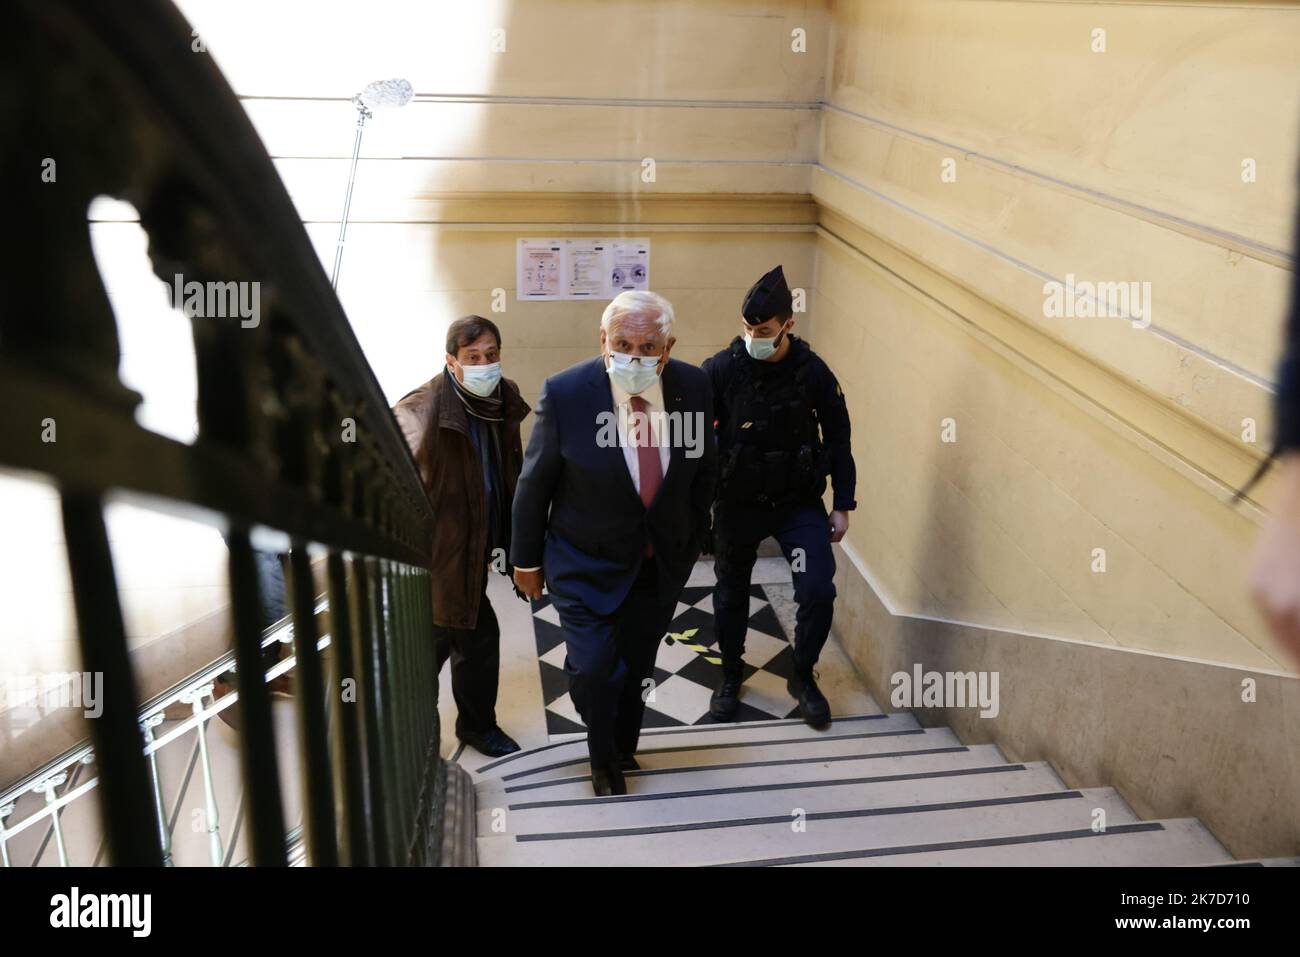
476, 739, 1009, 809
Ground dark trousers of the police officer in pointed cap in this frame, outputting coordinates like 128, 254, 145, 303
714, 502, 835, 674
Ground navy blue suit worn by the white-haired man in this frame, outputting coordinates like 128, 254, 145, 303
510, 356, 716, 763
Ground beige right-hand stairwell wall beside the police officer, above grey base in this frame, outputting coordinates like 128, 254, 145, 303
813, 0, 1300, 670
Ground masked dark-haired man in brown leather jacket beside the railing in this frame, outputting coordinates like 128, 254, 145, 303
393, 316, 529, 757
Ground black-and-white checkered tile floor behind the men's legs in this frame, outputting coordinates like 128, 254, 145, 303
532, 585, 798, 739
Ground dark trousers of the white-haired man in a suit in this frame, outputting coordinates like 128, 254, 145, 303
551, 559, 677, 765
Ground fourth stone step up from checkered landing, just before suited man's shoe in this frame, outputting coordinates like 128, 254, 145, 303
477, 761, 1066, 837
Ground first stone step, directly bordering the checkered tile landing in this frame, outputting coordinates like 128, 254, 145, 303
471, 711, 920, 780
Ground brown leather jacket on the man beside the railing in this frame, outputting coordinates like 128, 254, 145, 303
393, 374, 529, 628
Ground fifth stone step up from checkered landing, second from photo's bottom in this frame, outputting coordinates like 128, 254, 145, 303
478, 788, 1138, 867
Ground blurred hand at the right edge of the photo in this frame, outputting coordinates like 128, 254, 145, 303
1251, 452, 1300, 664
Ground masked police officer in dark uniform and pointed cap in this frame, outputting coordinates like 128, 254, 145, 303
703, 267, 857, 728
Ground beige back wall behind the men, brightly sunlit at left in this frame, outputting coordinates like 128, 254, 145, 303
0, 0, 828, 733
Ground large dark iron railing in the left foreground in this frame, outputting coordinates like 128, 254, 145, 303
0, 0, 457, 865
